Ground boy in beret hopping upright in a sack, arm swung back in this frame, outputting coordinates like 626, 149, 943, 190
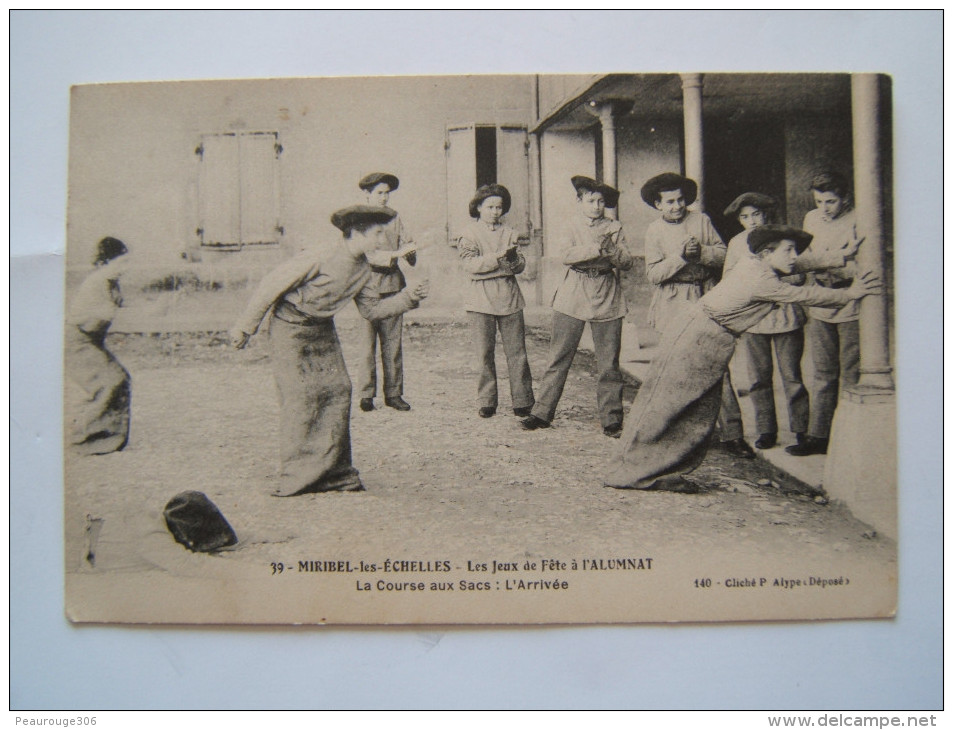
231, 205, 428, 497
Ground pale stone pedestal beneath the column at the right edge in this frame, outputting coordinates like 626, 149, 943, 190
824, 388, 897, 539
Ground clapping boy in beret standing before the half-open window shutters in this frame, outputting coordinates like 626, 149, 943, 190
458, 185, 533, 418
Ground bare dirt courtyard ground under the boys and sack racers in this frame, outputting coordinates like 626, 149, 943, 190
66, 314, 896, 584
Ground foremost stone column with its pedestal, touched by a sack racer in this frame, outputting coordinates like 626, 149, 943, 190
824, 74, 897, 538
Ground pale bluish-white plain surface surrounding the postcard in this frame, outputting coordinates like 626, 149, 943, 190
10, 11, 942, 710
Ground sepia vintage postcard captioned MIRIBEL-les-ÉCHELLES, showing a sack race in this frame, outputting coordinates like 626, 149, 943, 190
64, 72, 898, 624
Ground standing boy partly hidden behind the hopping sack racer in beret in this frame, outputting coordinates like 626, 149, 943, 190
357, 172, 417, 411
